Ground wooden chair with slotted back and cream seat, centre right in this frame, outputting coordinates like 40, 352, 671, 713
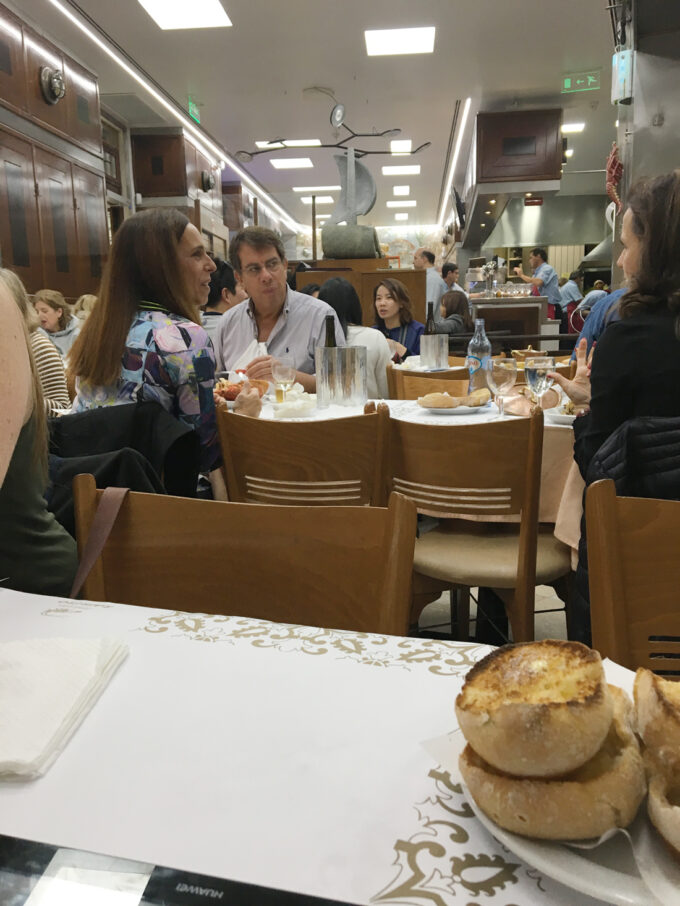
388, 410, 571, 642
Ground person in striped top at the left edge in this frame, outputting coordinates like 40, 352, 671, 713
0, 268, 71, 415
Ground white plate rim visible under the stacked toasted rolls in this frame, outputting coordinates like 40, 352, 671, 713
464, 786, 658, 906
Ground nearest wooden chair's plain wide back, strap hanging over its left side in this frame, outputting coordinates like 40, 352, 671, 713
73, 475, 416, 635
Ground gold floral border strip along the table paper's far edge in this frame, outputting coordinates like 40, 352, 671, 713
142, 611, 489, 676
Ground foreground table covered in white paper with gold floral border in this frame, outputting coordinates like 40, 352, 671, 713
0, 588, 620, 906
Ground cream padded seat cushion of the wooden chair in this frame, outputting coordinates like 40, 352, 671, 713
413, 521, 571, 588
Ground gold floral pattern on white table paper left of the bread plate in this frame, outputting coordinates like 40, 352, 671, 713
371, 767, 543, 906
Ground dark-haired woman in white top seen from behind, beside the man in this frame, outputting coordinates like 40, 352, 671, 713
319, 277, 392, 400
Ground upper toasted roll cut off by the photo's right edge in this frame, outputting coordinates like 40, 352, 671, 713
633, 667, 680, 777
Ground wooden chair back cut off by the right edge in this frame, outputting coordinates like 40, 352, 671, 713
586, 479, 680, 677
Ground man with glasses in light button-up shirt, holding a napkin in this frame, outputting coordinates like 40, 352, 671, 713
215, 227, 345, 393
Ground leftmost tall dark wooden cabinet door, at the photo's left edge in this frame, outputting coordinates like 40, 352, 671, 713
0, 130, 42, 292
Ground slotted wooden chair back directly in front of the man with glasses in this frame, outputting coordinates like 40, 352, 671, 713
217, 406, 389, 506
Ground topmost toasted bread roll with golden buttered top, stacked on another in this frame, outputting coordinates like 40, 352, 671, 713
456, 640, 612, 777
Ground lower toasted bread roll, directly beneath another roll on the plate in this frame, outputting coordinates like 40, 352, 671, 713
459, 687, 646, 840
